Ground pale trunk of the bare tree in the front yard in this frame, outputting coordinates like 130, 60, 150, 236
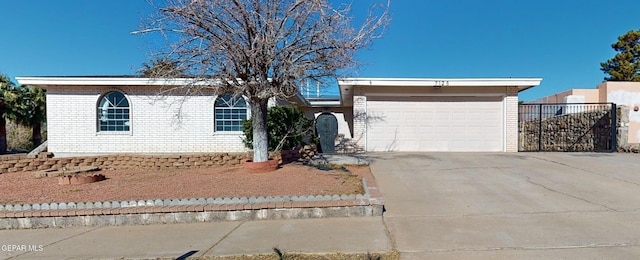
251, 99, 269, 162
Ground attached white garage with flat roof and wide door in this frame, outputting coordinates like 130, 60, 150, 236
338, 78, 542, 152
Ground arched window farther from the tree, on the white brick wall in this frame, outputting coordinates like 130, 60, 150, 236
98, 91, 131, 132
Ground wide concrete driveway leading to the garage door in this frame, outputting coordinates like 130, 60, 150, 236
370, 153, 640, 259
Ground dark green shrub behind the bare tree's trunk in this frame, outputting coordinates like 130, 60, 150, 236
242, 106, 317, 151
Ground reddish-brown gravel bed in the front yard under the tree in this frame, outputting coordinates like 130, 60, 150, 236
0, 163, 370, 204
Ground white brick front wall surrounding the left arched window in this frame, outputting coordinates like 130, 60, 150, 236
47, 86, 246, 154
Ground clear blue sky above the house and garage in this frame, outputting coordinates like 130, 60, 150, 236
0, 0, 640, 100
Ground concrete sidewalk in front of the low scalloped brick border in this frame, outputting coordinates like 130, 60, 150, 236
0, 217, 392, 259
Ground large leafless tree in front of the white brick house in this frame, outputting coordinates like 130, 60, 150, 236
134, 0, 390, 162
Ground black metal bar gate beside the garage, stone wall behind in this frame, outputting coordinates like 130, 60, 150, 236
518, 103, 617, 152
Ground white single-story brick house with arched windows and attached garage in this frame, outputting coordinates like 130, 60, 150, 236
16, 77, 541, 156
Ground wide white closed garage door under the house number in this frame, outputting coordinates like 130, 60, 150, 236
366, 96, 504, 151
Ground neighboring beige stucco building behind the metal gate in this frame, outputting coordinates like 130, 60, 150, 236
527, 81, 640, 144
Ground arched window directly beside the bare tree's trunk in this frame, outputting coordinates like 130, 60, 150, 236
214, 94, 247, 132
